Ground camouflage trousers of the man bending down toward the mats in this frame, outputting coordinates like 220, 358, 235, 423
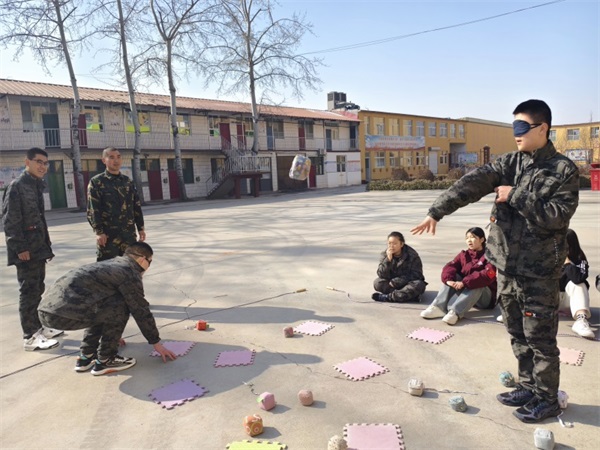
39, 294, 129, 360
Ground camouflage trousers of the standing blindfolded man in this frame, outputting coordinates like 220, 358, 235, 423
498, 270, 560, 401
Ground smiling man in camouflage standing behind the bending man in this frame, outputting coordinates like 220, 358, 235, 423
87, 147, 146, 261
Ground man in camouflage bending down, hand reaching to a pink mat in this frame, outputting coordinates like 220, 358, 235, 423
38, 242, 176, 375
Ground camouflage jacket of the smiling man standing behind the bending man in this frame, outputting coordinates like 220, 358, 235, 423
87, 170, 144, 237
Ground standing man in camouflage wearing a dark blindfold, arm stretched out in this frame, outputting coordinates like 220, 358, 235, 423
411, 100, 579, 423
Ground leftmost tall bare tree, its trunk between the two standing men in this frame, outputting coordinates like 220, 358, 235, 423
0, 0, 90, 210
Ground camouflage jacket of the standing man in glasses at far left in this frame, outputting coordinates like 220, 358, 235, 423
2, 171, 54, 266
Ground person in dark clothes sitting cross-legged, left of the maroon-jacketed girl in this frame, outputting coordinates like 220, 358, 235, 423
371, 231, 427, 303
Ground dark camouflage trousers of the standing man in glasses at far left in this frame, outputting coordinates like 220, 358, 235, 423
16, 260, 46, 339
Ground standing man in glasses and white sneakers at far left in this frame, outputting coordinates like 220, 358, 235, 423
2, 148, 63, 351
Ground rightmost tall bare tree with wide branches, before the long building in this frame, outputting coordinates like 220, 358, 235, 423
206, 0, 322, 154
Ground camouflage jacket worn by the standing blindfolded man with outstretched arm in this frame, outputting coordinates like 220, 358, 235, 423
428, 141, 579, 278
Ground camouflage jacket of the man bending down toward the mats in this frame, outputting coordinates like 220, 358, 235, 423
38, 256, 160, 344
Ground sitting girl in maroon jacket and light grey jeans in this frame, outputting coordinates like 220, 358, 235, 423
421, 227, 497, 325
